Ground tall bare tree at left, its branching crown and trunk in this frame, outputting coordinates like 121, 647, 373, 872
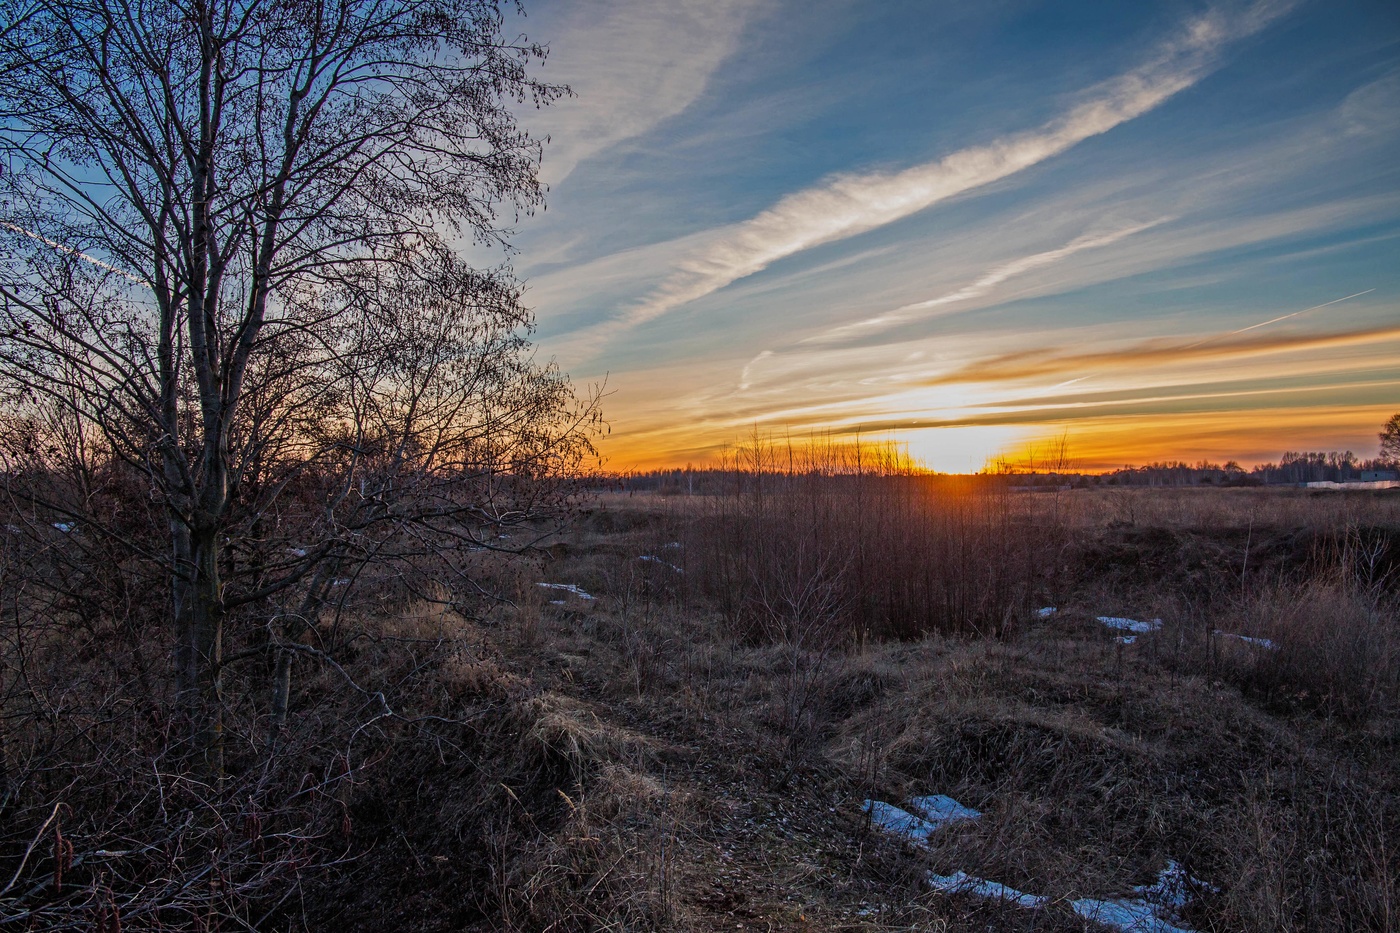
0, 0, 594, 772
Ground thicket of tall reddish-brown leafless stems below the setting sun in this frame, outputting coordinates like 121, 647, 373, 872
683, 474, 1064, 640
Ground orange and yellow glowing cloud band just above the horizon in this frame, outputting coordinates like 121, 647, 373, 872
590, 316, 1400, 472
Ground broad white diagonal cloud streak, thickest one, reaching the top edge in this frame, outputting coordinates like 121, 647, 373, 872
571, 1, 1292, 344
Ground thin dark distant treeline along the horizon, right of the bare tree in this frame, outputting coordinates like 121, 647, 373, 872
595, 450, 1397, 496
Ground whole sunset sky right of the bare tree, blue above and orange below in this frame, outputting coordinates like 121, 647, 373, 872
498, 0, 1400, 471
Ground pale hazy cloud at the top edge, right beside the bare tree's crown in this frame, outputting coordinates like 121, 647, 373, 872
529, 0, 763, 185
